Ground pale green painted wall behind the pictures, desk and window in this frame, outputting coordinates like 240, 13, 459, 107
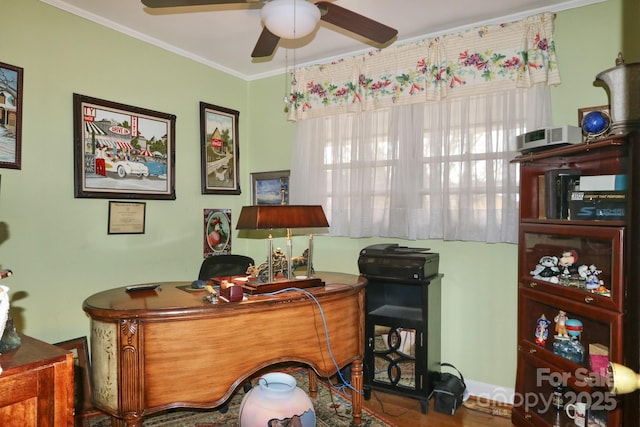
0, 0, 640, 394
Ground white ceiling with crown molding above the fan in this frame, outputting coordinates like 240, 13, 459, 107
41, 0, 606, 80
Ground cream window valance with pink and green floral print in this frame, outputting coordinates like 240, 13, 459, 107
289, 13, 560, 121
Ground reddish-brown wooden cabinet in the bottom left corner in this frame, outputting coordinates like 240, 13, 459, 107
0, 335, 74, 427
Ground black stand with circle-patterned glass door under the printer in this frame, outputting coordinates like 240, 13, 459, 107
359, 244, 442, 414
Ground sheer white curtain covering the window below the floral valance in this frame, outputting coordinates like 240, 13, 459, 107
290, 84, 550, 243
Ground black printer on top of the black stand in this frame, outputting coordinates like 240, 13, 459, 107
358, 243, 440, 282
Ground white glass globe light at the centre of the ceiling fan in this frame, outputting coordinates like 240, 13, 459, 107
261, 0, 320, 39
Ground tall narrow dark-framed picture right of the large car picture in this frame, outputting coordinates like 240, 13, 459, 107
200, 102, 240, 194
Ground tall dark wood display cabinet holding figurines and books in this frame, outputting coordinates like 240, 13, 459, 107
512, 134, 640, 427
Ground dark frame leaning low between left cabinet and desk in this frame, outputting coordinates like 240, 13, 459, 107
55, 337, 93, 415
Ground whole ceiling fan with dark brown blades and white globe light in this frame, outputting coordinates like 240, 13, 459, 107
141, 0, 398, 58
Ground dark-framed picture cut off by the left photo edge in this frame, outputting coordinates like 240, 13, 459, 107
0, 62, 23, 169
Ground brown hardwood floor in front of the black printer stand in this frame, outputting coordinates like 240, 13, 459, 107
363, 390, 512, 427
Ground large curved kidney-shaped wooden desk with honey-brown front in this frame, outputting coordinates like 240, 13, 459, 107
83, 273, 366, 427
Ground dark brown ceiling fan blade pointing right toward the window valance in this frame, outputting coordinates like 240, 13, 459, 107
316, 1, 398, 44
